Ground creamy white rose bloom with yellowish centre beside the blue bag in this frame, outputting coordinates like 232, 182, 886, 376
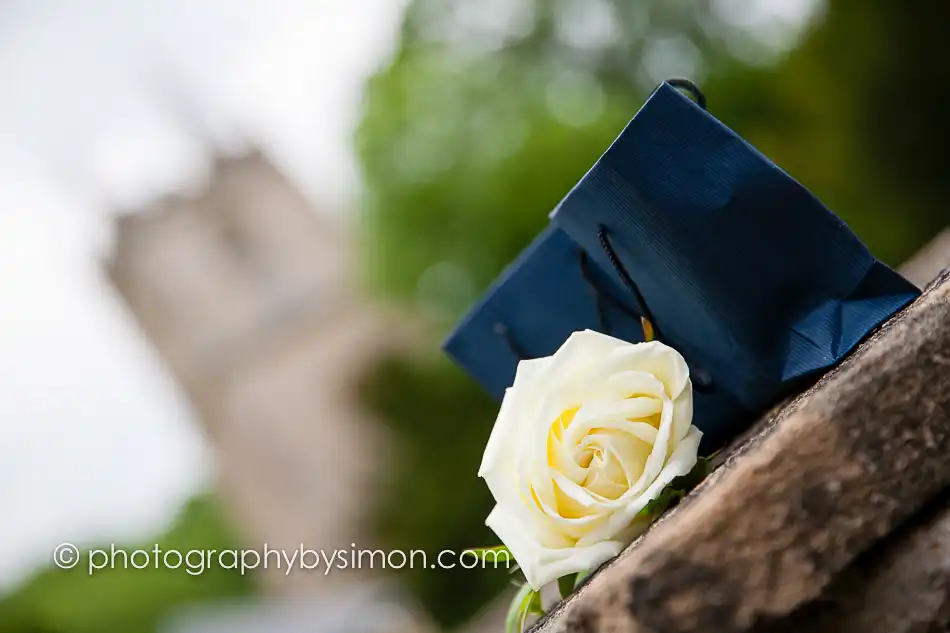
478, 330, 702, 589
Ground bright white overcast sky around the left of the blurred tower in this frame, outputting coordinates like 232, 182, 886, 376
0, 0, 402, 589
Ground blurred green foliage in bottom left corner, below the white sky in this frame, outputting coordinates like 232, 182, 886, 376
0, 497, 253, 633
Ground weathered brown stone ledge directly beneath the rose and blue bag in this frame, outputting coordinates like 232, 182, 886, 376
538, 272, 950, 633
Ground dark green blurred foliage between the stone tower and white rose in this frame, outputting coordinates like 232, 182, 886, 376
362, 358, 511, 626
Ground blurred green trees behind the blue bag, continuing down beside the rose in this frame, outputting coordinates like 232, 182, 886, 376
356, 0, 950, 625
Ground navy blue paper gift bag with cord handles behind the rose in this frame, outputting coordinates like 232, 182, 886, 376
445, 82, 919, 450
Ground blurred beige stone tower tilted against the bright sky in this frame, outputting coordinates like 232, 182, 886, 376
107, 151, 394, 594
